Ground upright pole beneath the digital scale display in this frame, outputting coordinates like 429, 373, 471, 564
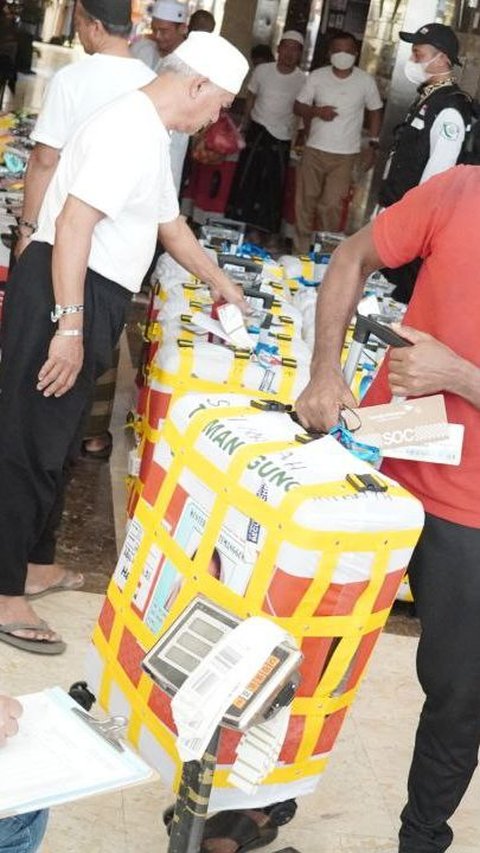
168, 727, 220, 853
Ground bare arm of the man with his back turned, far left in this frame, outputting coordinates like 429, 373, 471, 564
15, 142, 60, 258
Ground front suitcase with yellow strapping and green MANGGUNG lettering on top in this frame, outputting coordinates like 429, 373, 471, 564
88, 394, 423, 810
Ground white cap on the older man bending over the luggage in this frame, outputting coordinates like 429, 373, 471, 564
173, 31, 249, 95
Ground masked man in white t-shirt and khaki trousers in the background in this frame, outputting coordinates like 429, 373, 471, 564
295, 33, 382, 254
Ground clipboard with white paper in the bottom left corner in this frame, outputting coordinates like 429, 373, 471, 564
0, 687, 155, 818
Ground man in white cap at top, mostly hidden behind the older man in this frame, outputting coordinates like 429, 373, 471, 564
130, 0, 188, 71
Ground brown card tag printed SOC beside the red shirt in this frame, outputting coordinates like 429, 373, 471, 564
344, 394, 448, 451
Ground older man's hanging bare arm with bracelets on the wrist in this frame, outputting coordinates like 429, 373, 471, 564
37, 195, 104, 397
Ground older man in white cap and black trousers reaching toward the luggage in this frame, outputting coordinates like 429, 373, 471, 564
0, 33, 248, 654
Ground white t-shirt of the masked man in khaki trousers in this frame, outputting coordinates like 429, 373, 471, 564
297, 65, 382, 154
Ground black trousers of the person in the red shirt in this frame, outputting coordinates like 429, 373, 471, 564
400, 515, 480, 853
